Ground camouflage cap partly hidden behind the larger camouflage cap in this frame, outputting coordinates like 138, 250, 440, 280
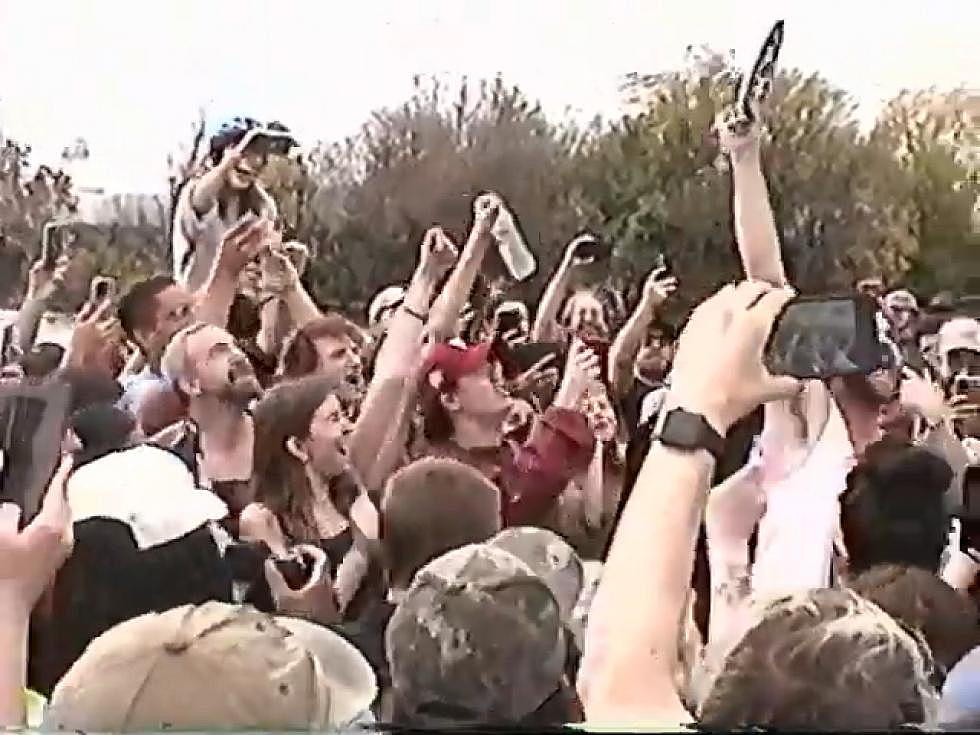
487, 526, 583, 623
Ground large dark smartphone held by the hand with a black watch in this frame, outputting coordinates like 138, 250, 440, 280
765, 296, 891, 380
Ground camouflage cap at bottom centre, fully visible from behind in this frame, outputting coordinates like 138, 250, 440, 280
385, 544, 567, 723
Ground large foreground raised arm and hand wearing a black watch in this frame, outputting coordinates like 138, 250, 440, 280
580, 283, 799, 728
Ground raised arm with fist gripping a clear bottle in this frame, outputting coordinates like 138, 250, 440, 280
427, 194, 502, 342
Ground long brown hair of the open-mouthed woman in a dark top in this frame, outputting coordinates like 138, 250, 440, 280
252, 376, 348, 541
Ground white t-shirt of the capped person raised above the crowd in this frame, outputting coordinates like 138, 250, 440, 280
171, 180, 276, 291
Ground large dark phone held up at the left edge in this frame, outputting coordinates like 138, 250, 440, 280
0, 381, 71, 524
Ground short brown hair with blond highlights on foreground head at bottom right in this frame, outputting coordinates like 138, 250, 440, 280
699, 589, 938, 730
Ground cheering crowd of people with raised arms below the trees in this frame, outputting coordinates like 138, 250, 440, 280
0, 96, 980, 732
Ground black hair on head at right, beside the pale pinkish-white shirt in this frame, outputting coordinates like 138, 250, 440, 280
841, 437, 953, 574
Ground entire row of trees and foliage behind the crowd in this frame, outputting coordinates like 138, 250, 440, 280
0, 60, 980, 315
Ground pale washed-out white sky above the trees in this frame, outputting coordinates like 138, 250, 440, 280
0, 0, 980, 191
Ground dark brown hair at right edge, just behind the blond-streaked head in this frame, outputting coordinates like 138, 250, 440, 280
850, 564, 980, 683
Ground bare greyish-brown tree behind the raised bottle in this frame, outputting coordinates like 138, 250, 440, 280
300, 77, 583, 311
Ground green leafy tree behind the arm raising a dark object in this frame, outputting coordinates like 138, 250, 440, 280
583, 49, 918, 314
